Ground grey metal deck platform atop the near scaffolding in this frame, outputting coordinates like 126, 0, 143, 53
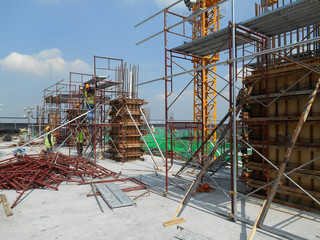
172, 0, 320, 57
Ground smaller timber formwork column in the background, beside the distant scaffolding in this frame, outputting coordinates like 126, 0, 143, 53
108, 98, 147, 162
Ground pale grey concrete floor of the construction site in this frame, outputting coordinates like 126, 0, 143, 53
0, 142, 320, 240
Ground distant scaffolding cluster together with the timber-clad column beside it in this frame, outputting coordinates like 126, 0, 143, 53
37, 56, 146, 162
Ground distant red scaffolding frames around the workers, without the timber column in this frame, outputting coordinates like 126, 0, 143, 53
37, 56, 130, 162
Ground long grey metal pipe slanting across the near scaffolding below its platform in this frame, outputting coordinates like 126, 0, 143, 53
135, 37, 320, 86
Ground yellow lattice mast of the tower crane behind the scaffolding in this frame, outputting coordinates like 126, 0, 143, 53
193, 0, 221, 146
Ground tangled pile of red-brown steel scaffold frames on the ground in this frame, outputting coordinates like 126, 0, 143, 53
0, 151, 119, 208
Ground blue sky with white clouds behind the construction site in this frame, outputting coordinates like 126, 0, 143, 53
0, 0, 255, 120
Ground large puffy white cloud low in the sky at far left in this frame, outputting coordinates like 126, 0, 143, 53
0, 48, 90, 77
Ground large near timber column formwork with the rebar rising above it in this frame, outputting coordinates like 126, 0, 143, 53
242, 0, 320, 214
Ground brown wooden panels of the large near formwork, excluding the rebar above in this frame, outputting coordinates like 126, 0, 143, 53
243, 59, 320, 212
